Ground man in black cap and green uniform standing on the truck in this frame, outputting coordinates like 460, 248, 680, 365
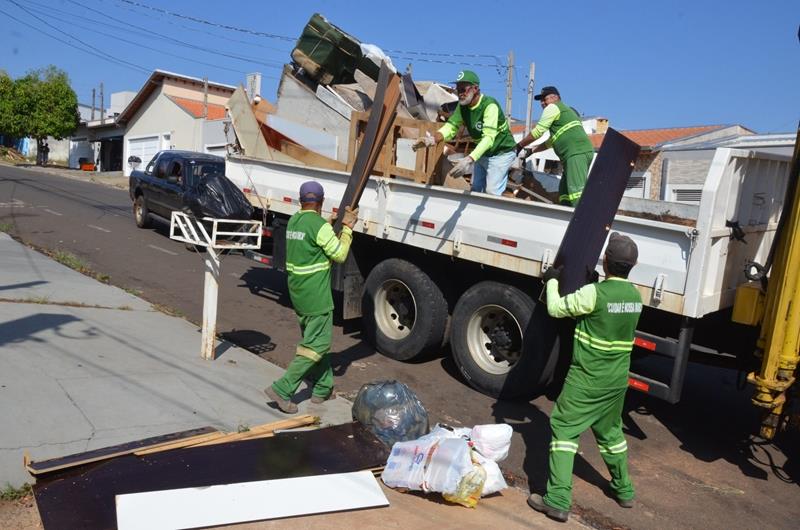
516, 86, 594, 207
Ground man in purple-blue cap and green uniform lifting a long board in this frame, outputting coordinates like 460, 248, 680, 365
264, 181, 358, 414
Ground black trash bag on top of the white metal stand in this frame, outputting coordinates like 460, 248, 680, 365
183, 173, 253, 220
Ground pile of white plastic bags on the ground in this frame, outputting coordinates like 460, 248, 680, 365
381, 423, 513, 508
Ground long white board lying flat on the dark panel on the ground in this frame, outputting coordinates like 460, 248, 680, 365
116, 471, 389, 530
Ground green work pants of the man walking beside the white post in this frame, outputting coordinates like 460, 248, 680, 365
272, 311, 333, 399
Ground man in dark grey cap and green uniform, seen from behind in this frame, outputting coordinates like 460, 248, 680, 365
528, 232, 642, 521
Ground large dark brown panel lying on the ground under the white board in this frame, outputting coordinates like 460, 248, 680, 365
33, 423, 389, 530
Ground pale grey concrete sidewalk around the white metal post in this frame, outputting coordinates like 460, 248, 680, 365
0, 233, 351, 487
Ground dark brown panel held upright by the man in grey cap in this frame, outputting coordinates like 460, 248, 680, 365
553, 129, 640, 296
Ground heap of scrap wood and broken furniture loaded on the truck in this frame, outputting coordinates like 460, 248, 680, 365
228, 14, 470, 188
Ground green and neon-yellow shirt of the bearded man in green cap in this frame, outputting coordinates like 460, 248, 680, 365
439, 94, 517, 161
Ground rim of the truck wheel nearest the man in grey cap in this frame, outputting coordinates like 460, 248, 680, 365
467, 305, 522, 375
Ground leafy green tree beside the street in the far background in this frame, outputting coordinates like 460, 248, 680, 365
0, 65, 80, 163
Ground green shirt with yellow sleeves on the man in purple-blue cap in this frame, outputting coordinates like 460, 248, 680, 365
286, 210, 353, 316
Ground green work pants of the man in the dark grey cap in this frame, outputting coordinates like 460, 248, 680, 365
544, 383, 634, 511
